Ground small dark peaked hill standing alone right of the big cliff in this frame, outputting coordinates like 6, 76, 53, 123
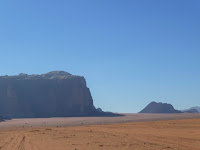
139, 102, 182, 113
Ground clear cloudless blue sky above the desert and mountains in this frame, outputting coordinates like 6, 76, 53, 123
0, 0, 200, 112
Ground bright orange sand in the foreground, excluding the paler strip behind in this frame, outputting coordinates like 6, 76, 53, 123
0, 116, 200, 150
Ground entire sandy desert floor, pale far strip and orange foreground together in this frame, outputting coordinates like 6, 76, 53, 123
0, 114, 200, 150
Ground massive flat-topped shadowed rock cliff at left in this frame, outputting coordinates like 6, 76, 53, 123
0, 71, 97, 118
